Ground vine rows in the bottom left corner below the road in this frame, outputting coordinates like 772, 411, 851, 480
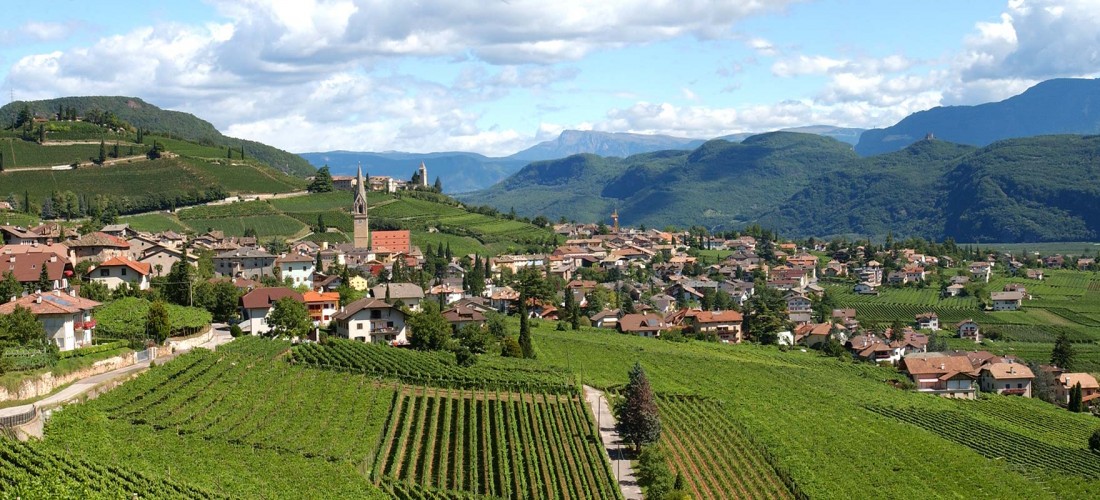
0, 438, 222, 499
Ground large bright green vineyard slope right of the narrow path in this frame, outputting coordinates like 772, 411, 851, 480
532, 324, 1064, 498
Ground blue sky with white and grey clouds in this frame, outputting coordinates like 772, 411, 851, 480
0, 0, 1100, 156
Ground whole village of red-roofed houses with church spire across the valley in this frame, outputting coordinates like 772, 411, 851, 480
0, 159, 1100, 419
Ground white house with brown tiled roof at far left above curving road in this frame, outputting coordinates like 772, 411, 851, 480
0, 290, 99, 351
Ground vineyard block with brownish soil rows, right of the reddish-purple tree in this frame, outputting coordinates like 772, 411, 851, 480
658, 396, 799, 499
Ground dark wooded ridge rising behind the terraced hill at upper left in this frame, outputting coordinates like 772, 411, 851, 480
0, 96, 316, 177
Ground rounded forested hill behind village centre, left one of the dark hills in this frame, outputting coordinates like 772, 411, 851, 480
462, 132, 858, 227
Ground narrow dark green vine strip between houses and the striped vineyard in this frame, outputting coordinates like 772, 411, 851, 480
290, 340, 576, 393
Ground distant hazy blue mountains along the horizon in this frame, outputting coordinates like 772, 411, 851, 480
300, 125, 862, 193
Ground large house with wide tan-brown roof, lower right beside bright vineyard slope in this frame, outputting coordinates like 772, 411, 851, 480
899, 353, 978, 399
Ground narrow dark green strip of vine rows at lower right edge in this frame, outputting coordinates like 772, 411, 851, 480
867, 405, 1100, 479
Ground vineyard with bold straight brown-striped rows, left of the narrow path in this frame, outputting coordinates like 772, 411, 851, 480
372, 388, 620, 499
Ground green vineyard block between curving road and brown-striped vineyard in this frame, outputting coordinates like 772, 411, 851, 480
90, 349, 392, 460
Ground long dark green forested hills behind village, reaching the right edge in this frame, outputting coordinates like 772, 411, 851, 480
461, 132, 1100, 242
